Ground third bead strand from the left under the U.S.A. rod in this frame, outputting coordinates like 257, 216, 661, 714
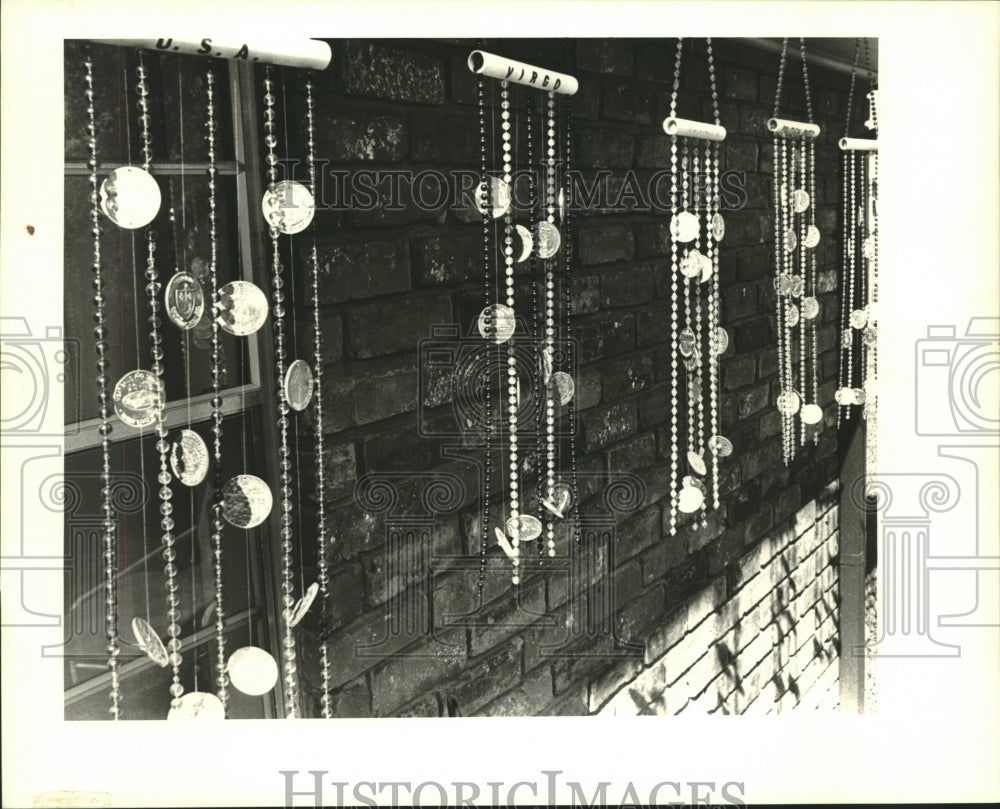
205, 62, 229, 710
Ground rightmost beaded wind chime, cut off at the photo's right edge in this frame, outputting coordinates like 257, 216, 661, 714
835, 39, 878, 469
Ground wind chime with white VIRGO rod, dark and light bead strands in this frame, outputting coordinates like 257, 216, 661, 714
468, 50, 580, 591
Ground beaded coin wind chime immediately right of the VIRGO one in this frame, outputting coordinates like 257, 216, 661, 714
663, 38, 733, 534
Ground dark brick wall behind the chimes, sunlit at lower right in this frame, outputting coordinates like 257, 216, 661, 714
288, 39, 861, 716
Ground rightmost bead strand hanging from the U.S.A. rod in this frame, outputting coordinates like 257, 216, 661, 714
306, 78, 333, 719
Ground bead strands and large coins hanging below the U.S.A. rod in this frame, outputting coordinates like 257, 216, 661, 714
85, 41, 330, 719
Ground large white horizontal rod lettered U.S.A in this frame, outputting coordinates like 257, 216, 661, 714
86, 37, 333, 70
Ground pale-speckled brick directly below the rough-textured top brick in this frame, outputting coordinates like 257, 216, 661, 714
315, 111, 407, 163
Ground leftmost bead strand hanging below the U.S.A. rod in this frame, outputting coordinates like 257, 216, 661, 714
84, 50, 122, 719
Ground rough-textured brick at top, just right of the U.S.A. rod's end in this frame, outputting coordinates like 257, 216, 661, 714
340, 42, 444, 104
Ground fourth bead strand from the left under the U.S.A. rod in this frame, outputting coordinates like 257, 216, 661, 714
264, 65, 298, 719
